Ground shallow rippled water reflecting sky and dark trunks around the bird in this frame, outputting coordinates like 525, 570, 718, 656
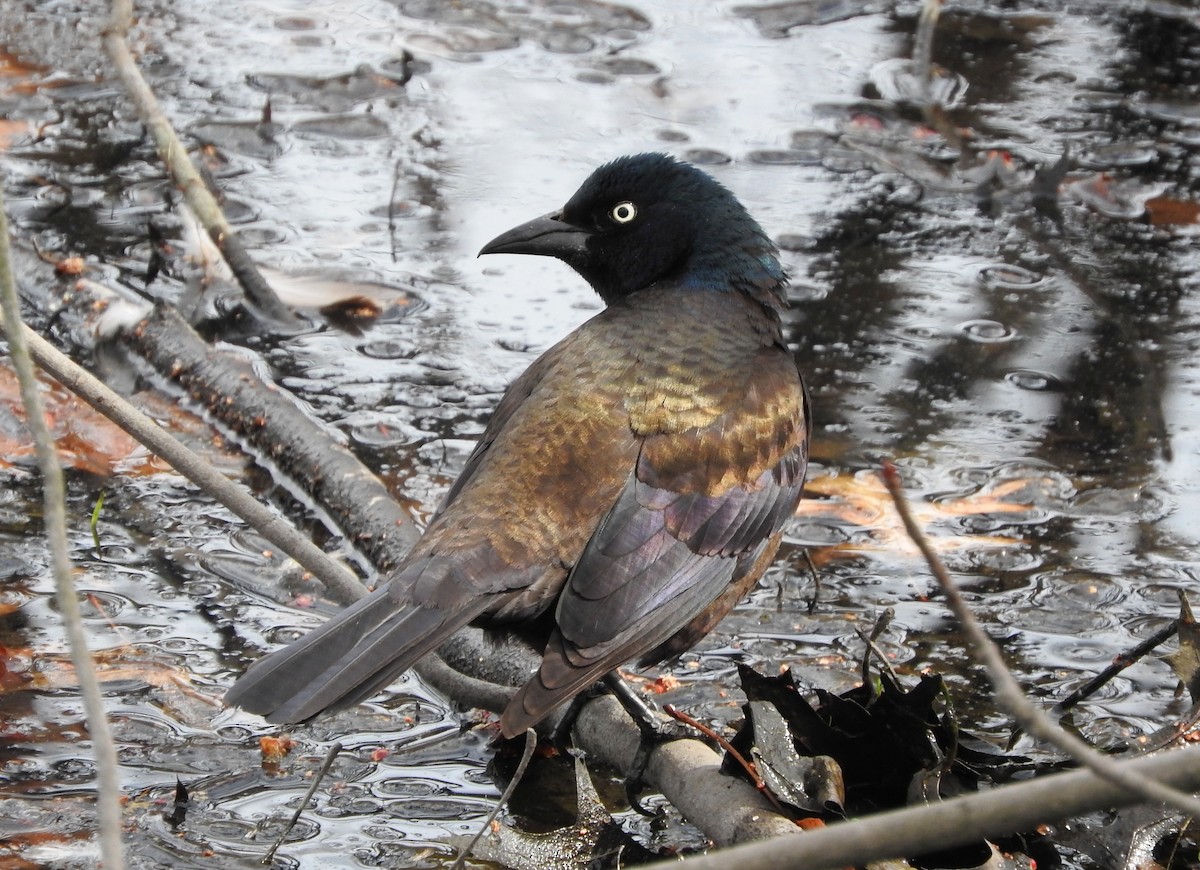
0, 0, 1200, 866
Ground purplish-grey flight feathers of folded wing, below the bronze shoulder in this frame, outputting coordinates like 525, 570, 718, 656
502, 439, 806, 734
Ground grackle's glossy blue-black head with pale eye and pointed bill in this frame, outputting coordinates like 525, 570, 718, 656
480, 154, 786, 311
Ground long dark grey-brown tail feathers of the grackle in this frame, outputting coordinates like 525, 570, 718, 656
226, 559, 492, 724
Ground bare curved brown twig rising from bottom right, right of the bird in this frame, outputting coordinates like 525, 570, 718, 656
883, 462, 1200, 816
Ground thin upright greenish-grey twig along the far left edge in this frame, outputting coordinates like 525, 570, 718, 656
0, 188, 125, 870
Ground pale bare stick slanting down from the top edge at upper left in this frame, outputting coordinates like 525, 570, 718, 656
101, 0, 296, 324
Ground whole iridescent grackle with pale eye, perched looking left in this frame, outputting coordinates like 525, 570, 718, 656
226, 154, 809, 737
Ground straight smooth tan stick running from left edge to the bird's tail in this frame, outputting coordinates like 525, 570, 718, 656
16, 326, 366, 601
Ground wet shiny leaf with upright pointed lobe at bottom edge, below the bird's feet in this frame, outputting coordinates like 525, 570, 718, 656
463, 757, 655, 870
